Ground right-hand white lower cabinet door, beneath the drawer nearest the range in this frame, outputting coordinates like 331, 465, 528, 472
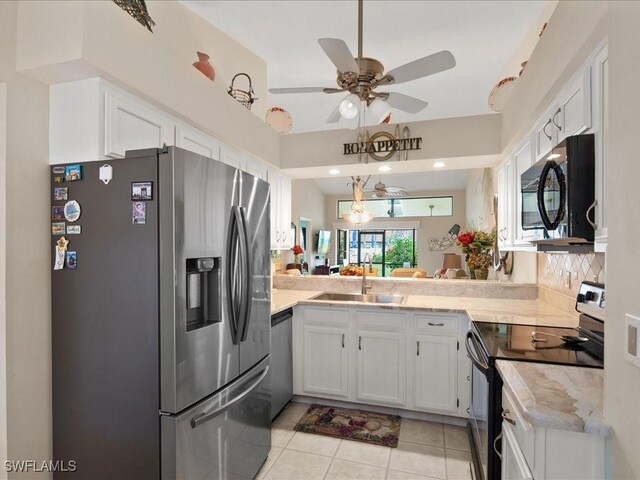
413, 335, 458, 414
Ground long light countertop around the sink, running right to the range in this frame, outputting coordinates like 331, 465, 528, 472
296, 290, 578, 327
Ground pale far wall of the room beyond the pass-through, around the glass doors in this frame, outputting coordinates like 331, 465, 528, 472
325, 190, 466, 276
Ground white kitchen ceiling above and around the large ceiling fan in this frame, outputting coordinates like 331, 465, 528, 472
183, 0, 548, 132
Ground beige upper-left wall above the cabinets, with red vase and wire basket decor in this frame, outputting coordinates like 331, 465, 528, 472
17, 0, 280, 166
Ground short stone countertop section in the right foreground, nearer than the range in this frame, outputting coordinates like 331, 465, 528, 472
496, 360, 611, 436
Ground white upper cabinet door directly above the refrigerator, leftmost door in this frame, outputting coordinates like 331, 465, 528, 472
104, 90, 175, 158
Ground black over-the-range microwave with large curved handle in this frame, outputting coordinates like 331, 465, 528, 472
519, 134, 596, 246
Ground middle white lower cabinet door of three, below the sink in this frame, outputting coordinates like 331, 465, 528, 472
356, 330, 406, 405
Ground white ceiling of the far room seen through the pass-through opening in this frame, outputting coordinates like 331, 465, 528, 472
315, 170, 471, 195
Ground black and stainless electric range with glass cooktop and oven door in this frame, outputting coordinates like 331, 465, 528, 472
466, 282, 606, 480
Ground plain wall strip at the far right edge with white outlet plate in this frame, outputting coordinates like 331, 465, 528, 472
605, 2, 640, 478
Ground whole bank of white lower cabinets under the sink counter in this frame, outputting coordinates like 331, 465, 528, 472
293, 305, 469, 417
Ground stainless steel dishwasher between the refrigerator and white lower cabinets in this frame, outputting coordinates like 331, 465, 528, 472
271, 308, 293, 420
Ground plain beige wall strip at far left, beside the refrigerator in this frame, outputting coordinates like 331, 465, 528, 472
0, 2, 52, 478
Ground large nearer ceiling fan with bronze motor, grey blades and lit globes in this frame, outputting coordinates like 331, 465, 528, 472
269, 0, 456, 123
